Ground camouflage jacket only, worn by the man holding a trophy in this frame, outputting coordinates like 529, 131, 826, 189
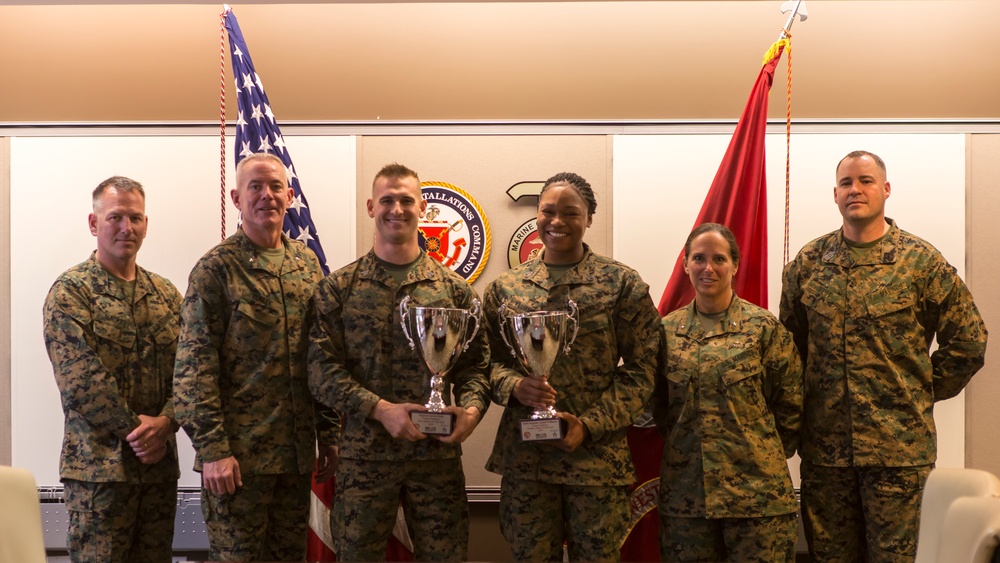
309, 251, 489, 461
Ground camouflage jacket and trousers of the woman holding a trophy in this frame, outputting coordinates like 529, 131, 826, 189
484, 244, 662, 561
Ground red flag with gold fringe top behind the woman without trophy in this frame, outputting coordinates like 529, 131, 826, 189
621, 0, 806, 561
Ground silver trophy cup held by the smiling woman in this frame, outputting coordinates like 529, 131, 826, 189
497, 299, 580, 442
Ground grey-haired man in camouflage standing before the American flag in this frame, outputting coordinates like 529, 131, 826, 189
174, 154, 336, 561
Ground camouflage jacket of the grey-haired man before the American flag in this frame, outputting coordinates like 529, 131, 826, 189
174, 230, 336, 475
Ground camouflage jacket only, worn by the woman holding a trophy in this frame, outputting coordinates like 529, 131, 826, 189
484, 245, 661, 486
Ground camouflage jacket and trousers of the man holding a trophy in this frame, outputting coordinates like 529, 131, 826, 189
309, 251, 489, 561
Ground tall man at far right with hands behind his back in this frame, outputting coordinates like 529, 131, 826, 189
780, 151, 987, 562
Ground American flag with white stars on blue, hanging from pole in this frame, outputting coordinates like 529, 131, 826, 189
222, 6, 413, 561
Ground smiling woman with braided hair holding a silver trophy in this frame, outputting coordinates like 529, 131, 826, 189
483, 173, 662, 561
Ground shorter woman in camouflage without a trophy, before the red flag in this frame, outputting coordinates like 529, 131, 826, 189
653, 223, 802, 562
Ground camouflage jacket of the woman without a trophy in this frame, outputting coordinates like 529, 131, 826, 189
653, 296, 802, 518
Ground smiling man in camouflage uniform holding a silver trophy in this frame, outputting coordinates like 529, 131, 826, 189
309, 164, 490, 561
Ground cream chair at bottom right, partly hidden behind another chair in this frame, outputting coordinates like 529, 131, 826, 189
916, 468, 1000, 563
